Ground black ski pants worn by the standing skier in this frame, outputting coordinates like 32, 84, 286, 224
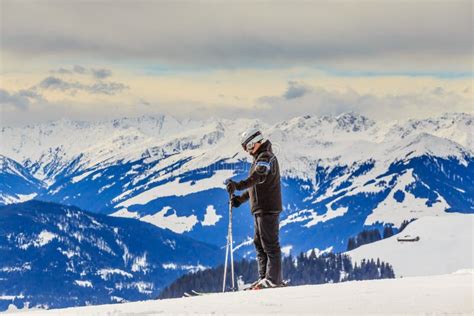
253, 213, 282, 285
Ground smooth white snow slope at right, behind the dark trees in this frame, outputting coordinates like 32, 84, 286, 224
347, 213, 474, 277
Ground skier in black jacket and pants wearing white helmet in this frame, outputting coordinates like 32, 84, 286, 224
227, 129, 282, 289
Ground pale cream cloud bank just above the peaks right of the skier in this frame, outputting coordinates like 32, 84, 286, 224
254, 83, 474, 121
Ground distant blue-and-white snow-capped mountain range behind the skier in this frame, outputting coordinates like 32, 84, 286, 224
1, 113, 474, 255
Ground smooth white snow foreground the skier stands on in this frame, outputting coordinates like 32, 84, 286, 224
7, 270, 474, 316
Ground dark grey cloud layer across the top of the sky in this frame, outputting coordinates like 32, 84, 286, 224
2, 0, 473, 71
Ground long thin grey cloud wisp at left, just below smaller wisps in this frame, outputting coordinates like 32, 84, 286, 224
38, 76, 129, 95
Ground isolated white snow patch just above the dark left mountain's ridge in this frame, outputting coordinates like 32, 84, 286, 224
140, 206, 198, 234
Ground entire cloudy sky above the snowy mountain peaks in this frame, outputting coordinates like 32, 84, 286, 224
0, 0, 474, 125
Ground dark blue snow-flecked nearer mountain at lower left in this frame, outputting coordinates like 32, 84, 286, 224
0, 201, 222, 311
